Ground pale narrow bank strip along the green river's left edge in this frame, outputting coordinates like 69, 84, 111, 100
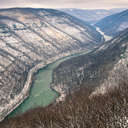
0, 49, 90, 121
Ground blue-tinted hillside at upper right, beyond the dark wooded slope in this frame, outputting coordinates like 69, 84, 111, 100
95, 10, 128, 36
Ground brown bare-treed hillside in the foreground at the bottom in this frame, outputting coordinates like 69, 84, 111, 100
0, 81, 128, 128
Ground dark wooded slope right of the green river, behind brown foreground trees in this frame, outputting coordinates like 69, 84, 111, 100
52, 29, 128, 98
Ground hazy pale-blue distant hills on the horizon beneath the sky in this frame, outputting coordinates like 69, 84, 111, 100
60, 8, 125, 24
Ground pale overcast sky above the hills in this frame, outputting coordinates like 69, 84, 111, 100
0, 0, 128, 9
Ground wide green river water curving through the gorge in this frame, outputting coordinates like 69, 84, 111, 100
7, 51, 87, 118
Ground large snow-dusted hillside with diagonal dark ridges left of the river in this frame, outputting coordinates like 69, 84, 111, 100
0, 8, 102, 120
